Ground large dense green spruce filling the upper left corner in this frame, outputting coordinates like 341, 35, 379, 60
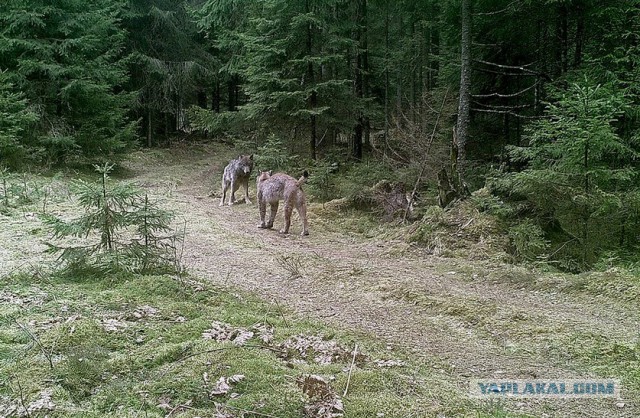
0, 0, 134, 163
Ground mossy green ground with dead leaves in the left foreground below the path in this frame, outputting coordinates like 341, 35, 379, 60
0, 274, 510, 417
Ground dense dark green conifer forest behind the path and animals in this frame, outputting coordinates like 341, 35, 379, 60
0, 0, 640, 270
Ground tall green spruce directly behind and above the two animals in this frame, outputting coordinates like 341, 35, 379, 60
192, 0, 370, 158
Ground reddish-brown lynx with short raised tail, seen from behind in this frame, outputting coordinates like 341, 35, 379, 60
256, 171, 309, 235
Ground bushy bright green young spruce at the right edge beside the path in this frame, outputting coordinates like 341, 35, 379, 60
510, 78, 639, 267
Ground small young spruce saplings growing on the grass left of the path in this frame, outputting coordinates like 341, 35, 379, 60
43, 164, 182, 272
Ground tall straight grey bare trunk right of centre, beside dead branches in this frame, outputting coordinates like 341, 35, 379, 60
456, 0, 471, 183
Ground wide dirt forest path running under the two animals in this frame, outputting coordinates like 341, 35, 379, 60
124, 148, 640, 417
